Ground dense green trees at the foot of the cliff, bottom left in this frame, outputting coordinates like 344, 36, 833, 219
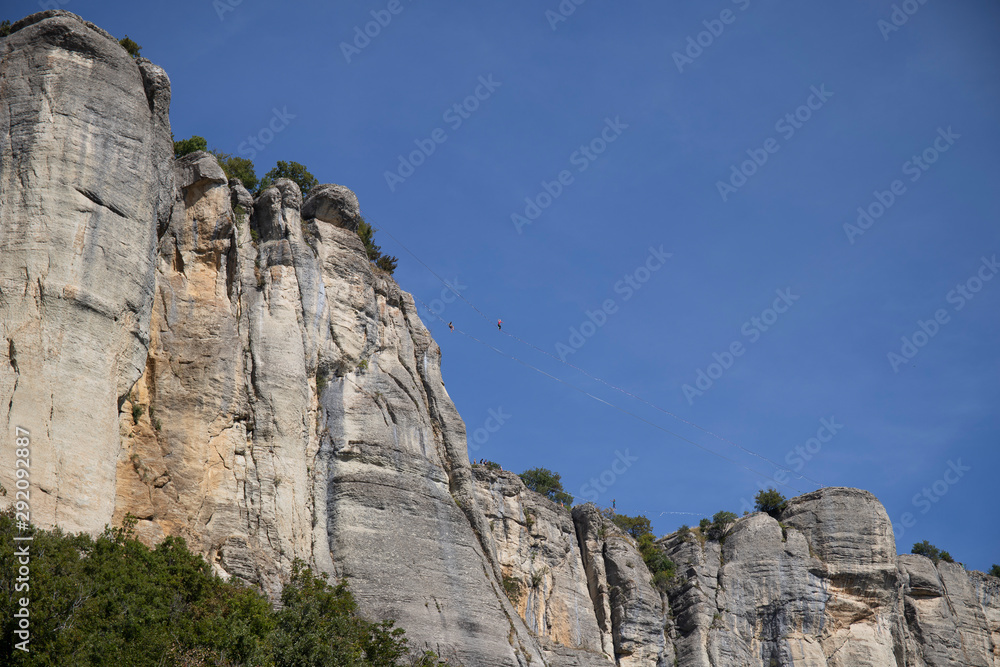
0, 512, 438, 667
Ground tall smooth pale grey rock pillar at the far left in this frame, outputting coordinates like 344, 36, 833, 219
0, 11, 173, 530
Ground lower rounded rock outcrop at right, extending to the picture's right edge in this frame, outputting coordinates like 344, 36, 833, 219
660, 488, 1000, 667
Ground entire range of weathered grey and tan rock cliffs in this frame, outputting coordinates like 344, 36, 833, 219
0, 11, 1000, 667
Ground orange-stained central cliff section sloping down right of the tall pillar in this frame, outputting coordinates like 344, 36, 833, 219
116, 153, 541, 665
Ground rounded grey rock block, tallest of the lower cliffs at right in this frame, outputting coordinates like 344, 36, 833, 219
663, 488, 900, 667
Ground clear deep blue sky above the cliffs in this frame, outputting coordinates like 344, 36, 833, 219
6, 0, 1000, 569
